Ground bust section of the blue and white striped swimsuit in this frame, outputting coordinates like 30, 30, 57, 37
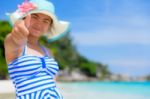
8, 55, 59, 76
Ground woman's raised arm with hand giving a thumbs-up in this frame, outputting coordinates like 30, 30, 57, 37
4, 16, 30, 63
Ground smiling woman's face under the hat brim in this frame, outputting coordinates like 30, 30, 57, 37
29, 13, 52, 37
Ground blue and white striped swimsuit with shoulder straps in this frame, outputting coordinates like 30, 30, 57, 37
8, 46, 63, 99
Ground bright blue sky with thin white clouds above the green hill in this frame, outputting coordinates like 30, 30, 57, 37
0, 0, 150, 77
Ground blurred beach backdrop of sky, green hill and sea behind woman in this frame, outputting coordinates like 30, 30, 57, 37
0, 0, 150, 99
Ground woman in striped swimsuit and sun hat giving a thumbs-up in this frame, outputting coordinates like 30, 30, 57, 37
4, 0, 69, 99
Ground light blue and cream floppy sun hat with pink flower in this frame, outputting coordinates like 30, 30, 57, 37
9, 0, 70, 42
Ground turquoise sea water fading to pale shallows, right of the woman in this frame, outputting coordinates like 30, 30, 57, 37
58, 82, 150, 99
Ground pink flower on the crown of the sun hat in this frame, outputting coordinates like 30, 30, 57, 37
18, 1, 36, 14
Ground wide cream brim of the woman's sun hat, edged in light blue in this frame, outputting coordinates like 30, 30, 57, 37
10, 10, 70, 42
